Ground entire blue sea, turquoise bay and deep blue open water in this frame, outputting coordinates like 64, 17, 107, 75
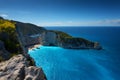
29, 27, 120, 80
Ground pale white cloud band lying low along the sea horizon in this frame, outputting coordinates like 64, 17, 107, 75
40, 19, 120, 26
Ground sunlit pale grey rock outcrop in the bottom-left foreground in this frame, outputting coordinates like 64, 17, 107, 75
0, 55, 46, 80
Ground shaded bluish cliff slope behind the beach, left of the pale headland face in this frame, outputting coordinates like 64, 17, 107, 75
14, 21, 46, 53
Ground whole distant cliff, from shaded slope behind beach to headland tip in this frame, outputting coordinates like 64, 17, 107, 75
14, 21, 102, 51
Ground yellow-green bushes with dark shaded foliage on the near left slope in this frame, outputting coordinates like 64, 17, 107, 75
0, 19, 22, 55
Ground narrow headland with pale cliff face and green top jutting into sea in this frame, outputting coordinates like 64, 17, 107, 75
42, 30, 102, 50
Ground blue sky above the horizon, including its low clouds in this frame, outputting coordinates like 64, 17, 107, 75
0, 0, 120, 26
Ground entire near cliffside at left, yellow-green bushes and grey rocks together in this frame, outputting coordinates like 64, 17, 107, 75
0, 18, 46, 80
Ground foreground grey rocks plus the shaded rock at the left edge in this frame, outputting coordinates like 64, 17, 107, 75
0, 41, 47, 80
